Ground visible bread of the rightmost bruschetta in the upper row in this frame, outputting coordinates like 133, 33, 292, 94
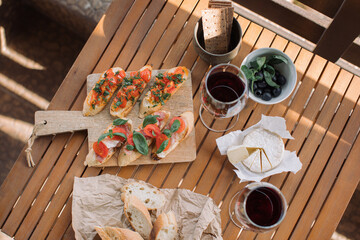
139, 67, 189, 118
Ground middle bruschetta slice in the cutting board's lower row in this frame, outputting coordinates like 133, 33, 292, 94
118, 110, 170, 166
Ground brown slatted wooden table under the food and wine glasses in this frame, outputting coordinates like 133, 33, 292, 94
0, 0, 360, 239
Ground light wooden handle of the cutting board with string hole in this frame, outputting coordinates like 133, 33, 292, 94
35, 111, 91, 136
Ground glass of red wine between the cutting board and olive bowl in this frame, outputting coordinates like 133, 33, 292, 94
199, 63, 249, 132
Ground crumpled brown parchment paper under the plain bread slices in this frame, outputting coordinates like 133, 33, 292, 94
72, 174, 222, 240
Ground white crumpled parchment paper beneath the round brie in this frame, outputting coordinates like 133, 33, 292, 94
216, 115, 302, 182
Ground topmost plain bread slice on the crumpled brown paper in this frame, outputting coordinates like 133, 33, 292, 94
121, 182, 166, 210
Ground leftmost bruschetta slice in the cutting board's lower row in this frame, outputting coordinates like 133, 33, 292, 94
84, 118, 133, 167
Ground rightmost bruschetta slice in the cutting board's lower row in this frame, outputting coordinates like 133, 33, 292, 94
151, 111, 194, 160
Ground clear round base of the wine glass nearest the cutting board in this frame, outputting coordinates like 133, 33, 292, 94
199, 104, 239, 132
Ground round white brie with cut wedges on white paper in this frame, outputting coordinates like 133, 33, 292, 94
242, 128, 284, 172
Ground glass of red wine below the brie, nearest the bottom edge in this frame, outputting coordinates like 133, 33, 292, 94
229, 182, 287, 232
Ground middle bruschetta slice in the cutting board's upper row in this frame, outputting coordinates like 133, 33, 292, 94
110, 65, 152, 118
